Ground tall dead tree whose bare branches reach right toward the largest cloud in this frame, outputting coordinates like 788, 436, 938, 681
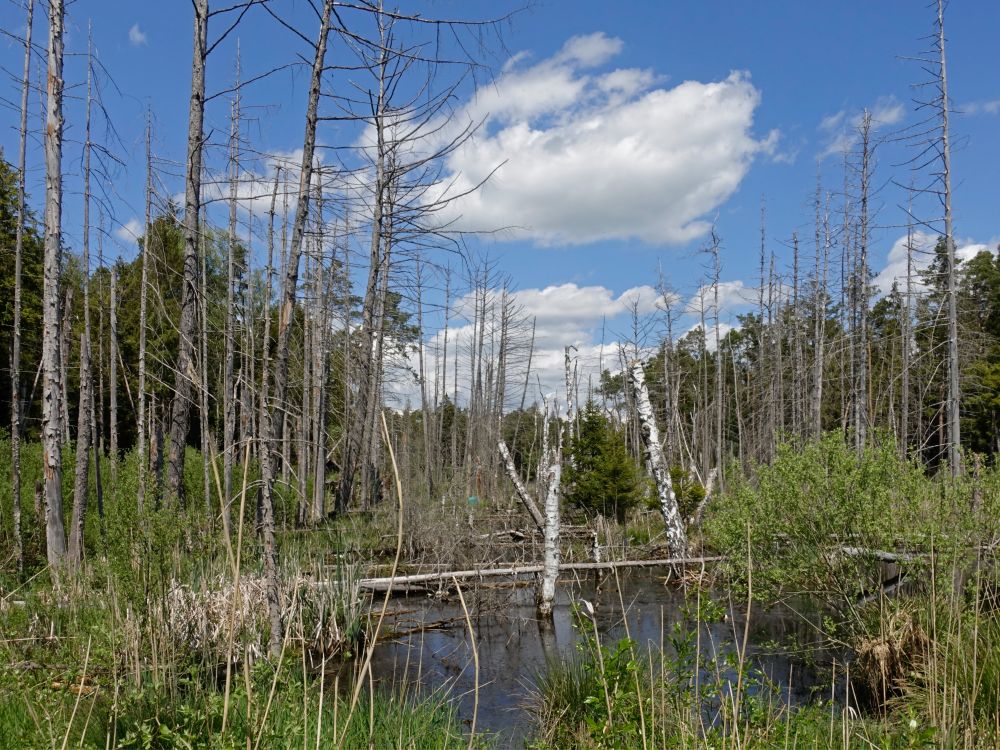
336, 2, 508, 511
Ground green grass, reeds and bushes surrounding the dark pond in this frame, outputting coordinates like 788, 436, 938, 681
0, 433, 1000, 748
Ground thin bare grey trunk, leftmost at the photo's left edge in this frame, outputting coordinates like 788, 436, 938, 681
10, 0, 35, 574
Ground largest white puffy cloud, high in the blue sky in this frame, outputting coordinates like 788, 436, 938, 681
430, 33, 777, 245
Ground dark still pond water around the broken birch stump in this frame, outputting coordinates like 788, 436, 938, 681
372, 568, 828, 747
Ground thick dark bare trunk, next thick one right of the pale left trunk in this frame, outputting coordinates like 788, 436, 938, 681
167, 0, 208, 502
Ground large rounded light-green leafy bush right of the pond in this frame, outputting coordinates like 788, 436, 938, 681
705, 432, 973, 611
